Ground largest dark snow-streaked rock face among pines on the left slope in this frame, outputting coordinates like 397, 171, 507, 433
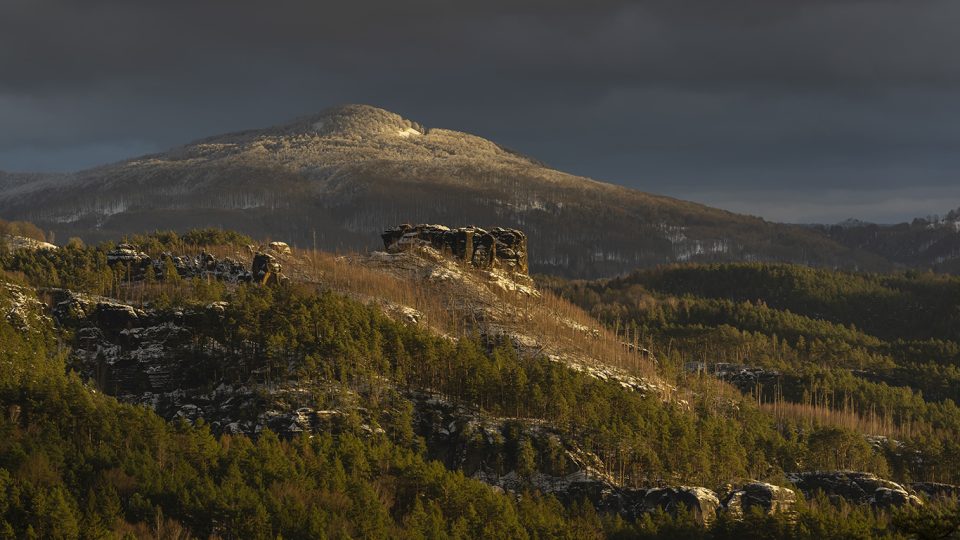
47, 290, 312, 436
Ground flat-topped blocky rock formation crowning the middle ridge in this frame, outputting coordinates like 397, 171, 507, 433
380, 224, 529, 274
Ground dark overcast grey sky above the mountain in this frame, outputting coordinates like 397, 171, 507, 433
0, 0, 960, 222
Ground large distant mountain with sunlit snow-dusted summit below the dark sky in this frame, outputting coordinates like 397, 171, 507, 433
0, 105, 936, 277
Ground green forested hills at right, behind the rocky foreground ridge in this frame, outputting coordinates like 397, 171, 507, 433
541, 263, 960, 482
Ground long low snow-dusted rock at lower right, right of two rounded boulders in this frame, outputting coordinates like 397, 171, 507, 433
787, 471, 922, 508
